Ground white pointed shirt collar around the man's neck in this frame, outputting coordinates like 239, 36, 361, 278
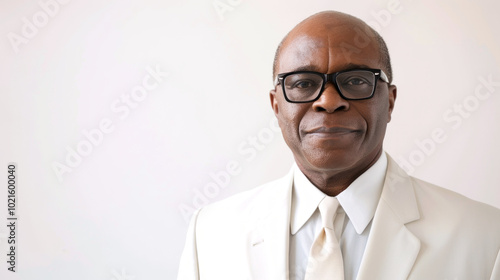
290, 153, 387, 235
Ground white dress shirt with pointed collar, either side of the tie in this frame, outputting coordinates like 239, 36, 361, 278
289, 153, 387, 280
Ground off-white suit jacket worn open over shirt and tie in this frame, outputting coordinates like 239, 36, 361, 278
178, 156, 500, 280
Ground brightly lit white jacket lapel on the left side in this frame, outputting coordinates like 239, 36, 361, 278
247, 171, 293, 280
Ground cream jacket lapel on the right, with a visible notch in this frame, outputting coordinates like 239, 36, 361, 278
357, 156, 420, 280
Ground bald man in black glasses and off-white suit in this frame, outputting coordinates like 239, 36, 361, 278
179, 11, 500, 280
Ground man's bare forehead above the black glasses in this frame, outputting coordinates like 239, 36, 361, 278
278, 24, 381, 73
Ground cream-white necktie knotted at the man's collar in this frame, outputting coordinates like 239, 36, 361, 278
305, 196, 344, 280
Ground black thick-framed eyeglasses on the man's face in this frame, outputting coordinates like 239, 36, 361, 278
274, 69, 389, 103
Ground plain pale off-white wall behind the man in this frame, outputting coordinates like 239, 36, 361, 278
0, 0, 500, 280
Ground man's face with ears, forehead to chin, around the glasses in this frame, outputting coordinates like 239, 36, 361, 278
270, 15, 396, 176
